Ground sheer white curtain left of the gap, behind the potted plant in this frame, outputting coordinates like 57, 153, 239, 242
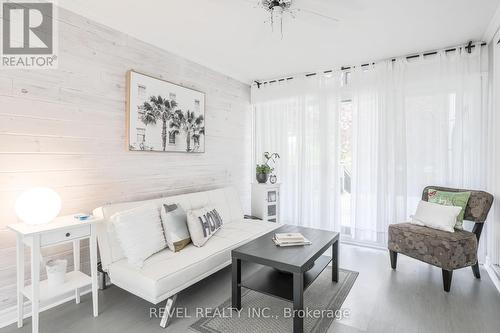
252, 74, 340, 230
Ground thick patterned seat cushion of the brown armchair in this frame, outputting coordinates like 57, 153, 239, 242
389, 223, 477, 270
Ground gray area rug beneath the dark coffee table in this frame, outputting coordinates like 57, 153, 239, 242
190, 268, 359, 333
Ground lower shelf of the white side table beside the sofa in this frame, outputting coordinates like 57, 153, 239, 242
23, 271, 92, 302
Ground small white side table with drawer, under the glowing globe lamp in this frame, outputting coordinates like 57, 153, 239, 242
8, 215, 100, 333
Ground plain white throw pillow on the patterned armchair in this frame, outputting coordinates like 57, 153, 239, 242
411, 200, 462, 232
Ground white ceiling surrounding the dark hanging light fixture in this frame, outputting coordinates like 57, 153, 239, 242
58, 0, 500, 83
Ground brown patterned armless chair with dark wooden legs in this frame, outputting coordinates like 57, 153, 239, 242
388, 186, 493, 292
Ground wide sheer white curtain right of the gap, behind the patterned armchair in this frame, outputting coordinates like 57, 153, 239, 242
351, 46, 488, 244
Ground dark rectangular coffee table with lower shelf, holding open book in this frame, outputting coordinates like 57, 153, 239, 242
231, 225, 339, 333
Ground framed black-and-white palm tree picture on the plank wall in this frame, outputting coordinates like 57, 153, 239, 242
127, 70, 205, 153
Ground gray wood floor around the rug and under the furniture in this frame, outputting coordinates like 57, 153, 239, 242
0, 245, 500, 333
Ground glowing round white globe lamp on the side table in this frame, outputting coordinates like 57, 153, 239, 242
16, 187, 61, 224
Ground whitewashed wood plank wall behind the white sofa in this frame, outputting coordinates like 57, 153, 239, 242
0, 8, 252, 314
